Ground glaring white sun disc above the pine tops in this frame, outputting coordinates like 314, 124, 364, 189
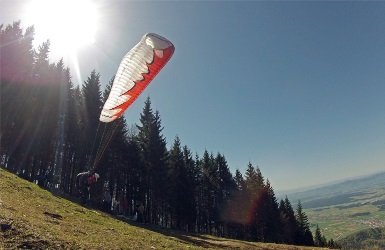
24, 0, 98, 54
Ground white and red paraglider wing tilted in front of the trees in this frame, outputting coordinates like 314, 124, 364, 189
99, 33, 175, 122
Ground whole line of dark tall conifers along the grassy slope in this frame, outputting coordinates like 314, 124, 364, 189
0, 22, 338, 246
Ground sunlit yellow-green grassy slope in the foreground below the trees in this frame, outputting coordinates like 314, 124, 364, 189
0, 169, 324, 250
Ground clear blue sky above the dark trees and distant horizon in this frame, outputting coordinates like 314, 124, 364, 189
0, 0, 385, 191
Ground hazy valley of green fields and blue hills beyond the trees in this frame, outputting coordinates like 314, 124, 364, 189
277, 172, 385, 239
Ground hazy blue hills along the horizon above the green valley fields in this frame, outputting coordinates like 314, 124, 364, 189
277, 172, 385, 209
